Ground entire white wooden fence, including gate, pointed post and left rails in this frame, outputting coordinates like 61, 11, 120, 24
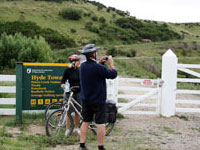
0, 50, 200, 117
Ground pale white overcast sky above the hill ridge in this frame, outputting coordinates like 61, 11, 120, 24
92, 0, 200, 23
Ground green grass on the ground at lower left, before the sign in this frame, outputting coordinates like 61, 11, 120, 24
0, 114, 96, 150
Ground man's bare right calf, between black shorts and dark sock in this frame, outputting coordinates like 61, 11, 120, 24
97, 124, 105, 146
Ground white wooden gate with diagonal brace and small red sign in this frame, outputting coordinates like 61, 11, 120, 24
117, 78, 161, 115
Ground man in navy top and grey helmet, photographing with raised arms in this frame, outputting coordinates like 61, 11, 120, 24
80, 44, 117, 150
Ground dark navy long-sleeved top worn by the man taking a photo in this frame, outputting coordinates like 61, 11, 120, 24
80, 60, 117, 104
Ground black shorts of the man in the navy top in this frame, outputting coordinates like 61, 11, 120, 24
82, 104, 106, 124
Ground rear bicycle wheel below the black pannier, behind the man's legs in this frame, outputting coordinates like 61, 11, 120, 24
89, 123, 115, 136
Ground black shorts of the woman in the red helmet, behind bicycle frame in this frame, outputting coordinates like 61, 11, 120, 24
64, 92, 81, 113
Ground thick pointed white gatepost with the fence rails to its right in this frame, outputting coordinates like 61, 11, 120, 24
161, 50, 200, 117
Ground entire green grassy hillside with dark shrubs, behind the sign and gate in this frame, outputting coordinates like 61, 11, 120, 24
0, 0, 200, 78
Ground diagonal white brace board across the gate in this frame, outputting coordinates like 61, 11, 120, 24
118, 89, 157, 113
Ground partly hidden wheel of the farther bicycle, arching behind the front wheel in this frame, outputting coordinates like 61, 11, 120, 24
44, 101, 63, 120
